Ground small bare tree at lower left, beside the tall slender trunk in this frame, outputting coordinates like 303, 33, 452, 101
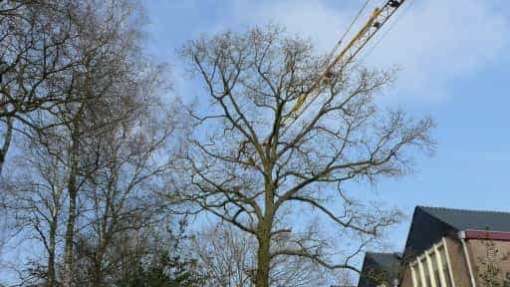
6, 138, 66, 286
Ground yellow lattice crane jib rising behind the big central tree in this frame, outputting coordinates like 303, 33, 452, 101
284, 0, 406, 125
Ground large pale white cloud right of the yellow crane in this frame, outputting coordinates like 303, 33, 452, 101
370, 0, 510, 103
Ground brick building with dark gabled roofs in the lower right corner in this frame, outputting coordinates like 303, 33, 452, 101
358, 206, 510, 287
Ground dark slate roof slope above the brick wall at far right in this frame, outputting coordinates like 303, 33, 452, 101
416, 206, 510, 231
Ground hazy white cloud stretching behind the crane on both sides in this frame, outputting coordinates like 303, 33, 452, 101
227, 0, 510, 105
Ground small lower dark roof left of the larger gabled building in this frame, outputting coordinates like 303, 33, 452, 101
358, 252, 402, 287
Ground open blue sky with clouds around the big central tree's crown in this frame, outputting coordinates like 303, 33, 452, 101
142, 0, 510, 254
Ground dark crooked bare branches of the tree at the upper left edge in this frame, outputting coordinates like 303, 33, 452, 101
0, 0, 81, 176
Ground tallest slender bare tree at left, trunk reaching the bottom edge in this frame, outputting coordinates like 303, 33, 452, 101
49, 1, 157, 286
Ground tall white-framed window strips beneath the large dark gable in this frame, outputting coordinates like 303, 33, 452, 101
410, 241, 452, 287
